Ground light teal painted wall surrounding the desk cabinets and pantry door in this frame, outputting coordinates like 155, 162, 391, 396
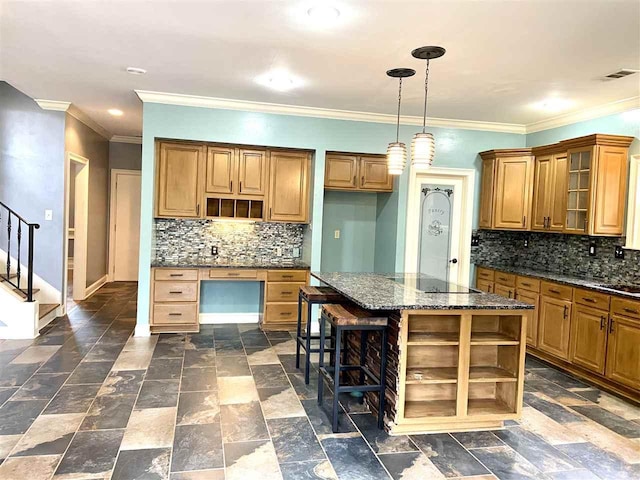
138, 103, 525, 326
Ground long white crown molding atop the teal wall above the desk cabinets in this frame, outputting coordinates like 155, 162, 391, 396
135, 90, 525, 134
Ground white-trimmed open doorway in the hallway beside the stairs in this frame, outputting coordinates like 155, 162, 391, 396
61, 152, 89, 314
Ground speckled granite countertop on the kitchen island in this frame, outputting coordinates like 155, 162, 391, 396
311, 272, 533, 310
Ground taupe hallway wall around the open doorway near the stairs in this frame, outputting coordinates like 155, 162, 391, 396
65, 114, 109, 286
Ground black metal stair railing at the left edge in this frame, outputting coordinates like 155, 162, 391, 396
0, 202, 40, 302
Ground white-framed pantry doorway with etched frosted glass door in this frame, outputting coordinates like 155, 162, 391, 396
405, 168, 475, 286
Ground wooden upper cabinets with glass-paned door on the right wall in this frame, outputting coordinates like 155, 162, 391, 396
479, 134, 633, 236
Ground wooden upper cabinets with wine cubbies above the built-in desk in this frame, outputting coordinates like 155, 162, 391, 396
156, 141, 311, 223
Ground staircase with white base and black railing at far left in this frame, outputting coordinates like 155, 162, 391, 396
0, 202, 61, 339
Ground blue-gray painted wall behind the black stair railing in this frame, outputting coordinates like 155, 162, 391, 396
0, 81, 65, 290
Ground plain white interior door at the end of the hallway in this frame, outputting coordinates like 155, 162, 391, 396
111, 172, 141, 282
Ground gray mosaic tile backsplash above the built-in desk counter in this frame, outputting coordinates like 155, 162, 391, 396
153, 218, 305, 265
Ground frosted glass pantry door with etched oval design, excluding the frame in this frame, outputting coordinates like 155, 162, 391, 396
418, 183, 457, 282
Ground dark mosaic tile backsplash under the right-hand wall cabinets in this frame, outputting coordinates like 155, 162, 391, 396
471, 230, 640, 285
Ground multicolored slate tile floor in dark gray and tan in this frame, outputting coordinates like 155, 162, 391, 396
0, 283, 640, 480
